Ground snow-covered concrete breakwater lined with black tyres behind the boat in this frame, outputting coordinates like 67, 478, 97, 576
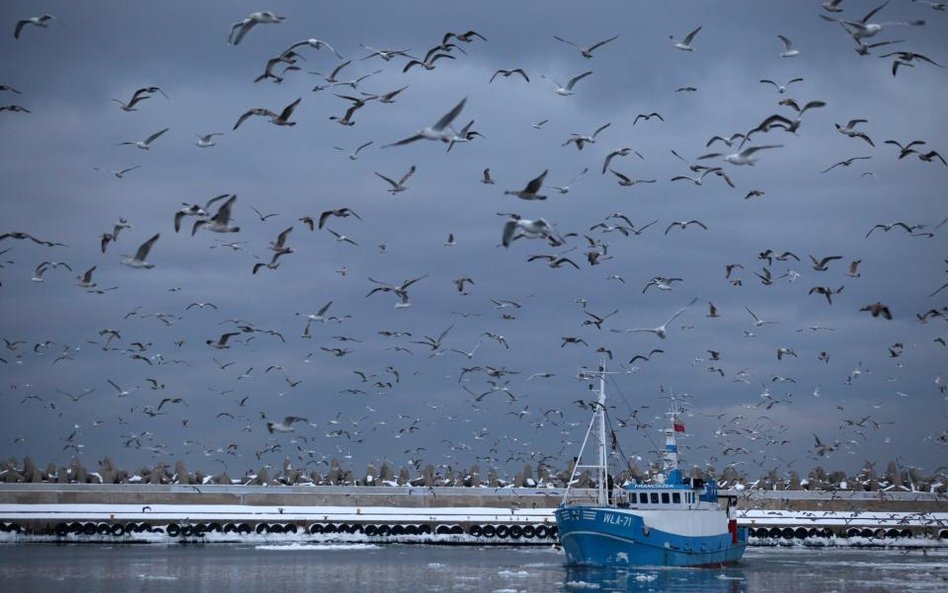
0, 484, 948, 546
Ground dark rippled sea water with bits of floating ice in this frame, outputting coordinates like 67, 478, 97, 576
0, 543, 948, 593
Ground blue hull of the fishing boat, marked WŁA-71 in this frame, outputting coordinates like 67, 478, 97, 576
556, 507, 747, 567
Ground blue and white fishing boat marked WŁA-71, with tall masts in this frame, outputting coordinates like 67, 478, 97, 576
556, 366, 748, 568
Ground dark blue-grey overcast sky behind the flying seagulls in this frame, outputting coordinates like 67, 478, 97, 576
0, 0, 948, 475
